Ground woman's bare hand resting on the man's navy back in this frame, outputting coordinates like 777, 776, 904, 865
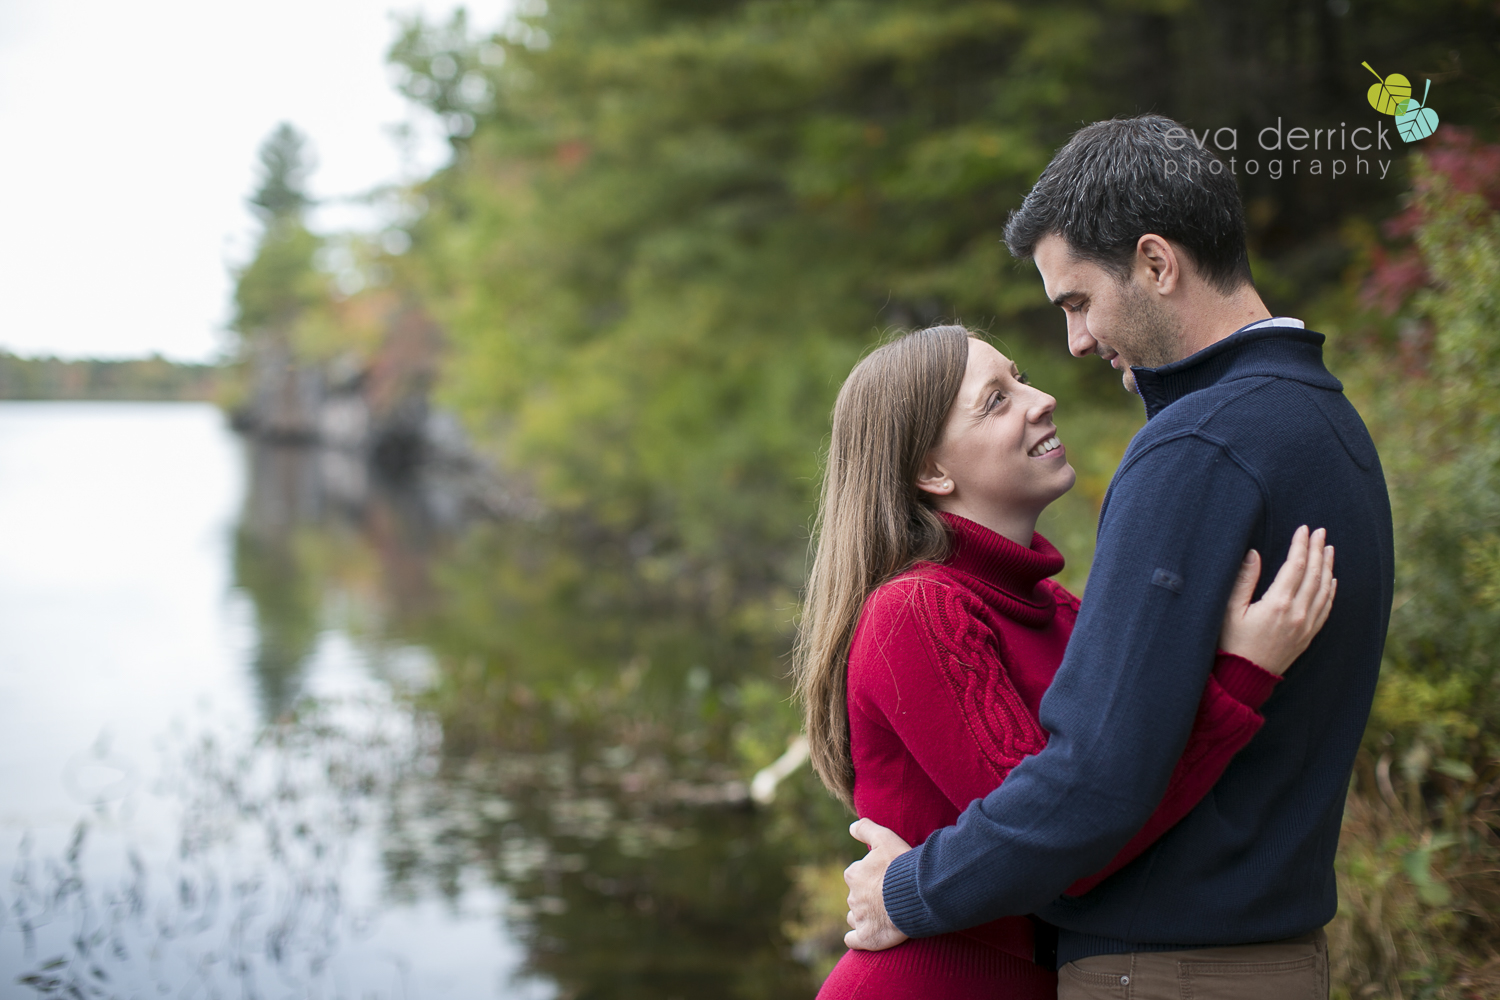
1220, 525, 1338, 676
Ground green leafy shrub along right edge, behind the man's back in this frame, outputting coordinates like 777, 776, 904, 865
1332, 130, 1500, 997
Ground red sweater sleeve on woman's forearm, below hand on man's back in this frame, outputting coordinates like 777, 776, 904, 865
1067, 649, 1281, 897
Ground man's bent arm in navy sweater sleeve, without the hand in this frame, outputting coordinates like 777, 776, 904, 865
882, 436, 1265, 937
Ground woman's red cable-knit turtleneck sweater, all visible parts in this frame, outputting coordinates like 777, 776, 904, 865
818, 514, 1280, 1000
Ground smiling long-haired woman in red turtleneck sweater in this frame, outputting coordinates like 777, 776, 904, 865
795, 327, 1335, 1000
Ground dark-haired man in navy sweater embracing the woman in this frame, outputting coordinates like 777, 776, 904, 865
846, 115, 1394, 1000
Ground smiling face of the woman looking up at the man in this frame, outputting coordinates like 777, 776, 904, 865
917, 339, 1077, 530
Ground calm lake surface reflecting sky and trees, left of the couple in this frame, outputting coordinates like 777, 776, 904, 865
0, 403, 837, 999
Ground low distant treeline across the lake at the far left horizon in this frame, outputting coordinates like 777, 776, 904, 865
0, 351, 219, 400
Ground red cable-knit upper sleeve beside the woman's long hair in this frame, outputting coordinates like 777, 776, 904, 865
849, 579, 1047, 834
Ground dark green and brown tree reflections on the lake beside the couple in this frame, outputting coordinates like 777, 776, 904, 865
236, 448, 845, 999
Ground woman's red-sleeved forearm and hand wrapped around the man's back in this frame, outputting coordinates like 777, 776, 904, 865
1067, 528, 1338, 897
